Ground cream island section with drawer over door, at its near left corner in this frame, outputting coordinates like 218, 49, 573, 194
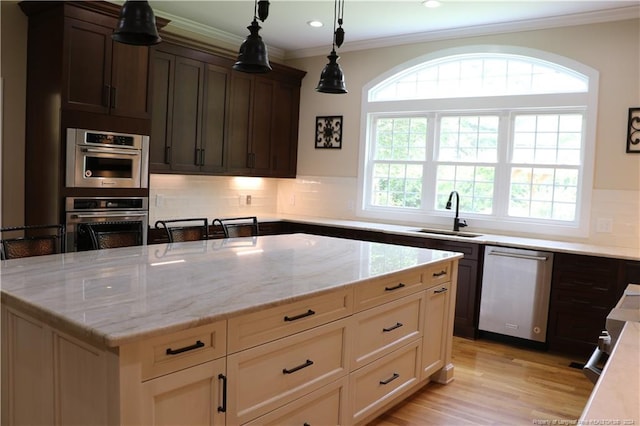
120, 321, 227, 426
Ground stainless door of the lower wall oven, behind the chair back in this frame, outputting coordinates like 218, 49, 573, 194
66, 210, 149, 251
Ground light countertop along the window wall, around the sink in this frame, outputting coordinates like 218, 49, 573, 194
266, 215, 640, 261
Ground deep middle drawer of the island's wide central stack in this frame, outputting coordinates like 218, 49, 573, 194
227, 319, 350, 424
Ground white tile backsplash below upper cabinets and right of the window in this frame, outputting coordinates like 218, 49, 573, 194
149, 174, 640, 248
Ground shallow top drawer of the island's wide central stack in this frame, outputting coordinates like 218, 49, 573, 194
228, 289, 353, 353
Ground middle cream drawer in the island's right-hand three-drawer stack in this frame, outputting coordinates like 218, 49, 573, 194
351, 292, 424, 370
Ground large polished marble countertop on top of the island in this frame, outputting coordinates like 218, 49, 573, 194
0, 234, 462, 347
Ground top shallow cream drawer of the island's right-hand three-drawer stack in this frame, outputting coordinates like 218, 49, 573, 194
354, 270, 426, 312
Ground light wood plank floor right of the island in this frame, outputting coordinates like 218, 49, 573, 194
369, 337, 593, 426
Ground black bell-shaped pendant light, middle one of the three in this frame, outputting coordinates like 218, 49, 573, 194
233, 0, 271, 73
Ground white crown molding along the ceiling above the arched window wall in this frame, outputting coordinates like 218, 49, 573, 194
284, 5, 640, 59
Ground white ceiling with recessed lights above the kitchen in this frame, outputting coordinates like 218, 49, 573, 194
149, 0, 640, 58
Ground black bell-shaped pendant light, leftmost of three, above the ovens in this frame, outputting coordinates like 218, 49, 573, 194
111, 0, 162, 46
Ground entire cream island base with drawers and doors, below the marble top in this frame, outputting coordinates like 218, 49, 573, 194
1, 259, 458, 426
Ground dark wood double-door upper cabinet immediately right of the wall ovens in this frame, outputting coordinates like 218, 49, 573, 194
149, 44, 230, 174
